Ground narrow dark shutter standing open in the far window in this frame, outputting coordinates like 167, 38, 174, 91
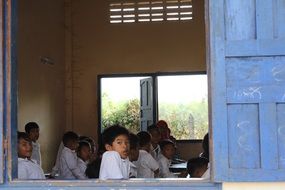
140, 78, 153, 131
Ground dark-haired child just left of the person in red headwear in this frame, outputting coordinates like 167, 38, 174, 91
147, 125, 161, 160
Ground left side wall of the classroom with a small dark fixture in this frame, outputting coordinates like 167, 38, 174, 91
17, 0, 65, 171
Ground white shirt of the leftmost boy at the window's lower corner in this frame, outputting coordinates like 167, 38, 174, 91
18, 158, 45, 179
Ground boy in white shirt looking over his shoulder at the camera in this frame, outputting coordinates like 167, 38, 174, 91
99, 125, 130, 180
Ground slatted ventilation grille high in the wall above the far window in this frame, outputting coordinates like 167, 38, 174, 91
110, 0, 193, 24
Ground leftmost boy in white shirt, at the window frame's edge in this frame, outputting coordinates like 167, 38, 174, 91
18, 132, 45, 179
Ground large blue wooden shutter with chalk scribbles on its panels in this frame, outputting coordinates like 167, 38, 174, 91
207, 0, 285, 181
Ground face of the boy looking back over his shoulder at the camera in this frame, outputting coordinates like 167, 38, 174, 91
105, 135, 130, 159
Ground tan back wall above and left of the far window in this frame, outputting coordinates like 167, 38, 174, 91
70, 0, 206, 140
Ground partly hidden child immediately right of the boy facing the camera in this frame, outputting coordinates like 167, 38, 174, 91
129, 133, 139, 178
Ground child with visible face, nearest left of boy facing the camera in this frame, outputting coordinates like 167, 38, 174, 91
77, 141, 91, 178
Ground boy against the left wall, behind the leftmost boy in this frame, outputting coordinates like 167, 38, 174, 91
25, 122, 42, 166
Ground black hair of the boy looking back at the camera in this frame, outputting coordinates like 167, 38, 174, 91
102, 125, 130, 145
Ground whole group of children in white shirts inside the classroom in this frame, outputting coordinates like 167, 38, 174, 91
18, 121, 209, 180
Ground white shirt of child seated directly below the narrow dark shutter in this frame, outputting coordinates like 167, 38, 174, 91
134, 150, 159, 178
